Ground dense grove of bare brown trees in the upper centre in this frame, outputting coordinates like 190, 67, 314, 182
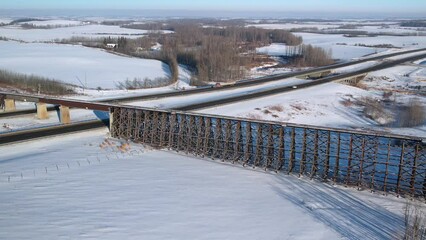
151, 21, 302, 82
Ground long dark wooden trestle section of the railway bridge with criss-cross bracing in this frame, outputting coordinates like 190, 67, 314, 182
110, 107, 426, 197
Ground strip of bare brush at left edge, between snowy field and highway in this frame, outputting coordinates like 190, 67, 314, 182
0, 70, 75, 95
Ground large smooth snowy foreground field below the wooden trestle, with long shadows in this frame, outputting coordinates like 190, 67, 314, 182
0, 130, 414, 240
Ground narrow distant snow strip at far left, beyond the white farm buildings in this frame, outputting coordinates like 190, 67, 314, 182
0, 24, 163, 42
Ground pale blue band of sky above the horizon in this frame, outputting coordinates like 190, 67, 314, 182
5, 0, 426, 13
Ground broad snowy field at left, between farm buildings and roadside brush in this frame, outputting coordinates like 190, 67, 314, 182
0, 41, 170, 89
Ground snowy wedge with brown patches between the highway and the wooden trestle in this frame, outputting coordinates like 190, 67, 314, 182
197, 81, 426, 137
